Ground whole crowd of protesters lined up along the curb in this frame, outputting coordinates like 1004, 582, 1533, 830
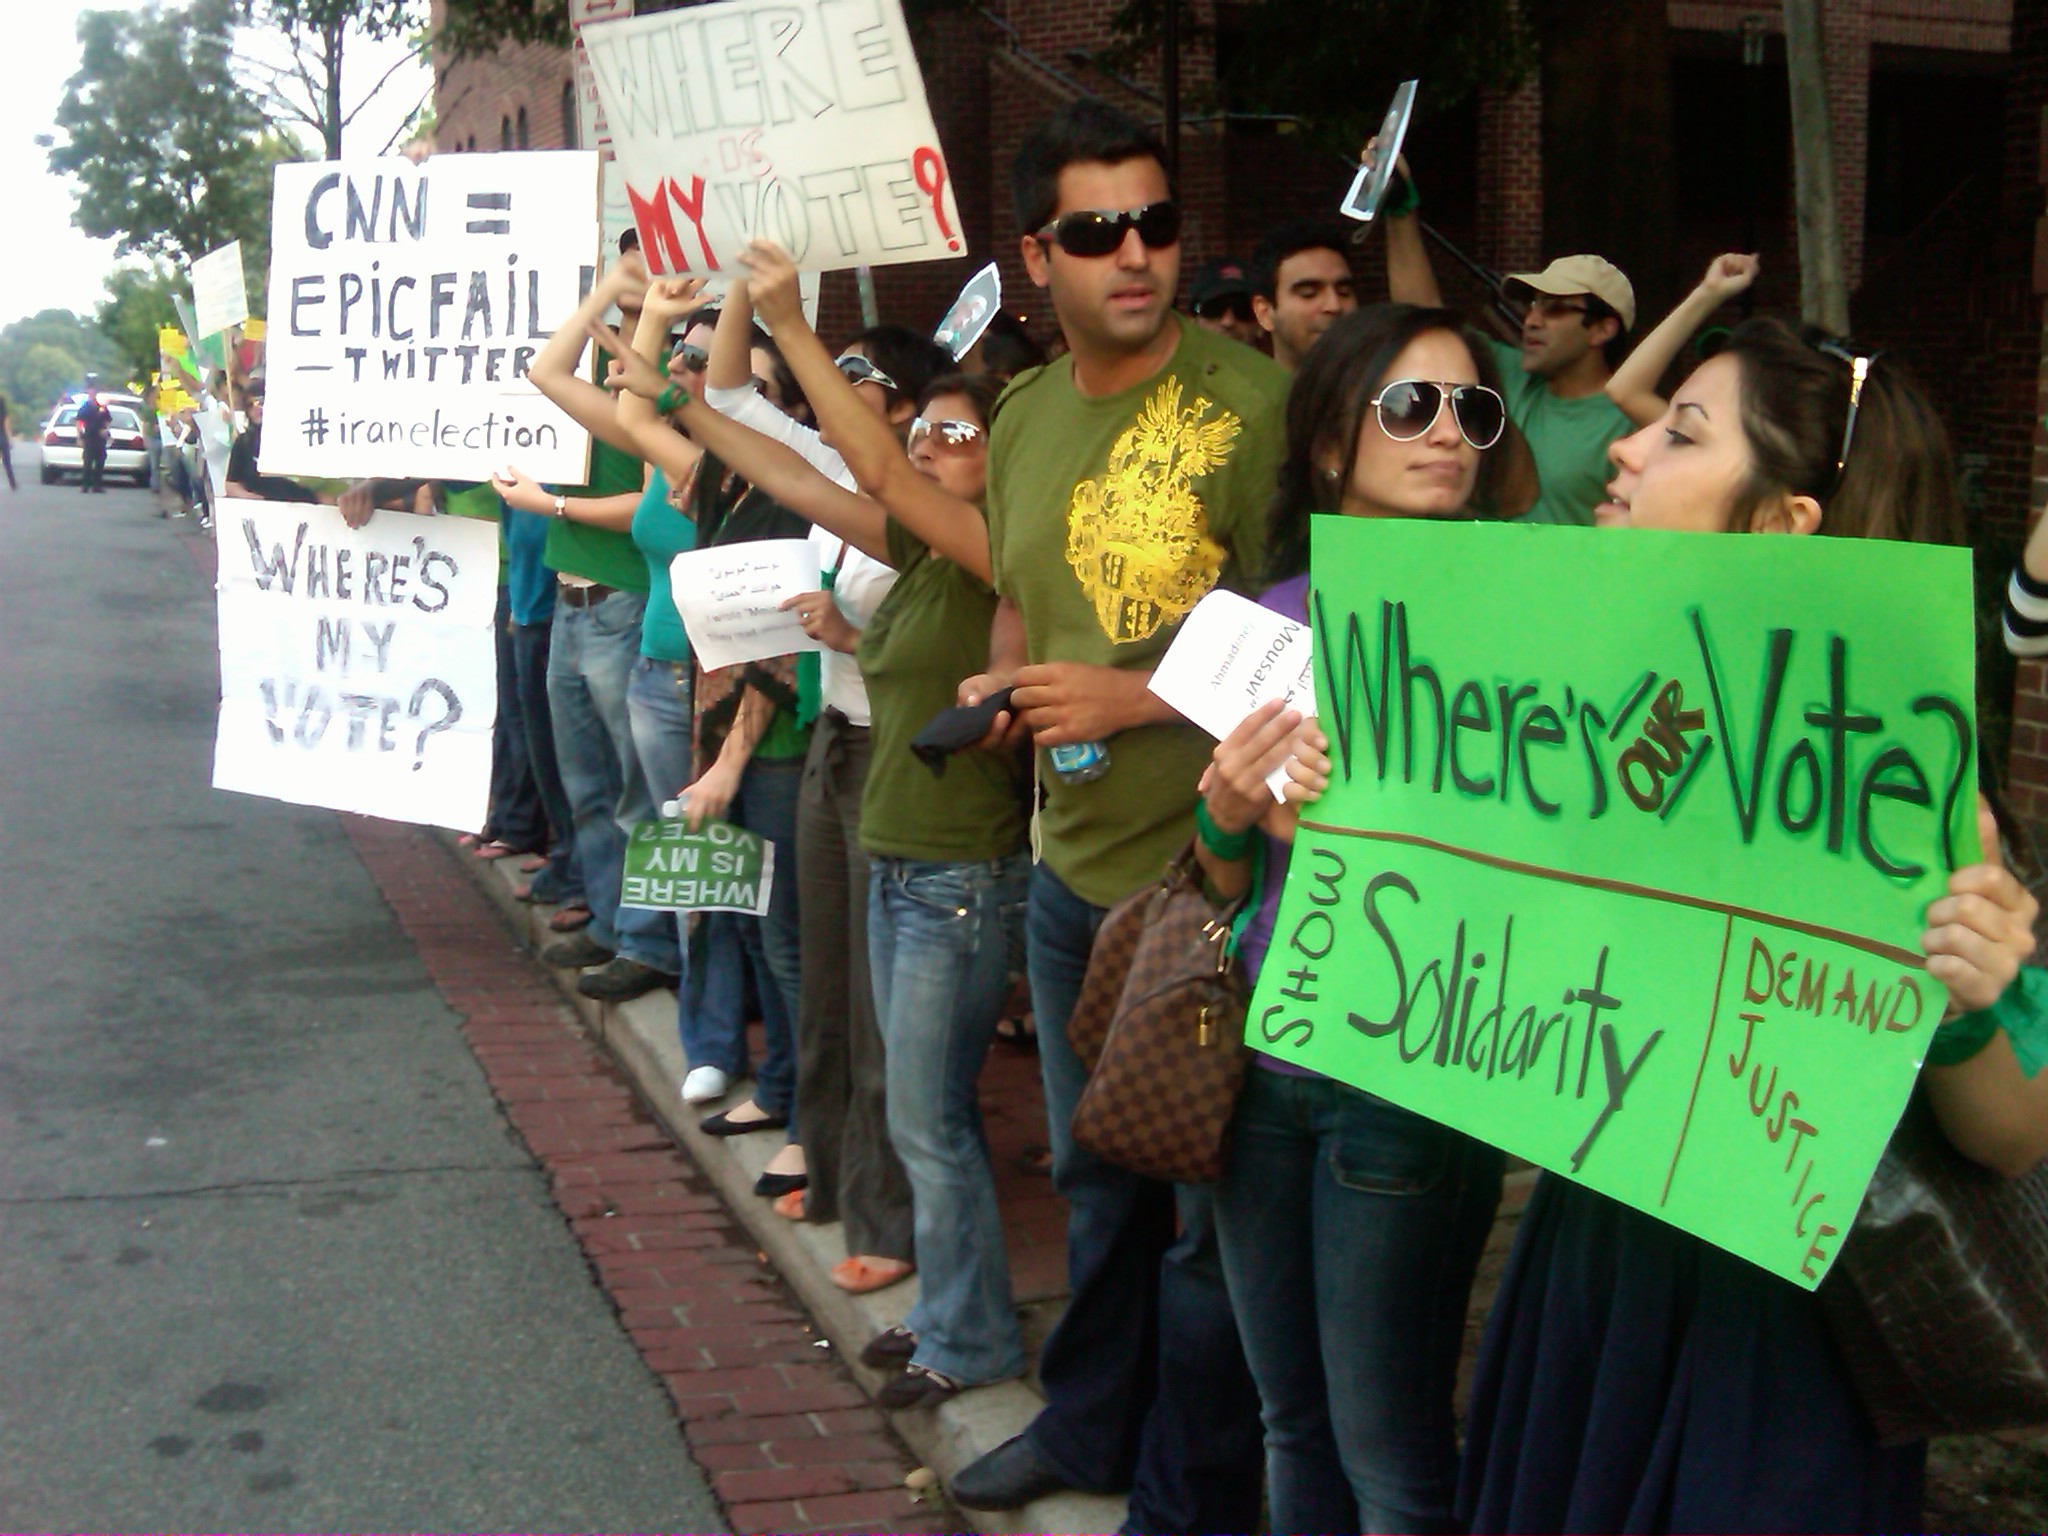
184, 100, 2048, 1532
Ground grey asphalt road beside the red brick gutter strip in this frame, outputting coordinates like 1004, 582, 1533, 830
0, 446, 719, 1530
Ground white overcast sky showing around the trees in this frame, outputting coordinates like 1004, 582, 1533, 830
0, 0, 428, 326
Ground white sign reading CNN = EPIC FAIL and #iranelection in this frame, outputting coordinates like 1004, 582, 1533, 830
262, 150, 598, 485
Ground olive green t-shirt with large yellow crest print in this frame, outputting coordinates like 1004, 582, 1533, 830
989, 322, 1288, 907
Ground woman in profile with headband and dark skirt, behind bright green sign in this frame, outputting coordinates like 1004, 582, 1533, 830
1460, 322, 2048, 1532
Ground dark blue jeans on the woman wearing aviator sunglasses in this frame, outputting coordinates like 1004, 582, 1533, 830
1217, 1067, 1505, 1532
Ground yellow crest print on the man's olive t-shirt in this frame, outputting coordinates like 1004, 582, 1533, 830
1067, 379, 1239, 645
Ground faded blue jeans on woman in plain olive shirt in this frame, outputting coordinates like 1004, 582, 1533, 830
868, 854, 1028, 1384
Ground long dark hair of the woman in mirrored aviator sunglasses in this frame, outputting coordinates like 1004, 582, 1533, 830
1266, 303, 1505, 582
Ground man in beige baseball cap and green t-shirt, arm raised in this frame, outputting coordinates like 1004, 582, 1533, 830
1382, 160, 1636, 528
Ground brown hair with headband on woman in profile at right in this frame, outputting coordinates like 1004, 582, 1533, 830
1722, 317, 1966, 545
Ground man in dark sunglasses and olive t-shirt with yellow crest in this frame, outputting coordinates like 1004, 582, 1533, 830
952, 100, 1286, 1530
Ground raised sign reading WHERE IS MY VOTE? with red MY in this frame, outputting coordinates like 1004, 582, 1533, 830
582, 0, 967, 276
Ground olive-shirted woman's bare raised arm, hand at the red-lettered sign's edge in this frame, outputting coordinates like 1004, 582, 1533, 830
739, 240, 989, 582
